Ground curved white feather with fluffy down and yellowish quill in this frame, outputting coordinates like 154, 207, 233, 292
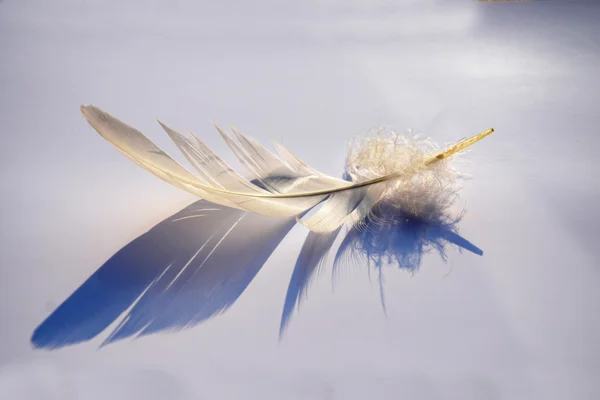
81, 105, 494, 232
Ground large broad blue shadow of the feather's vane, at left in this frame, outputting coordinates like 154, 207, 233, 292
31, 200, 296, 349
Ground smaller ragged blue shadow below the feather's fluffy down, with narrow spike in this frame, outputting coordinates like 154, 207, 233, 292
280, 199, 483, 338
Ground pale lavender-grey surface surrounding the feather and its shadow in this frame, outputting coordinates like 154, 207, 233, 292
0, 0, 600, 399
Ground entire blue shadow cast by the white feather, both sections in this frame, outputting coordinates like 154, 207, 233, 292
31, 200, 483, 349
